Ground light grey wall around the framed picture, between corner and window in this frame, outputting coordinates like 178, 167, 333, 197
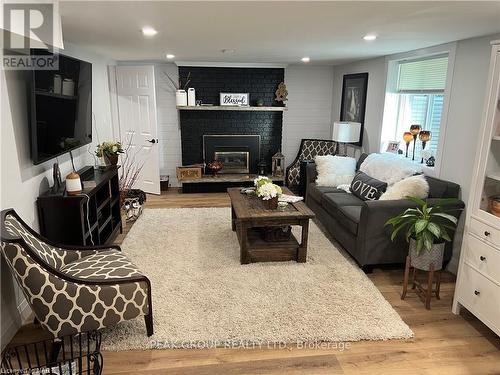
332, 57, 386, 153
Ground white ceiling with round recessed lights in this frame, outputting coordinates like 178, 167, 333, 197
60, 1, 500, 65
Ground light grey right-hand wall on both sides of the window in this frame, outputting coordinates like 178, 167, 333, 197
333, 34, 500, 272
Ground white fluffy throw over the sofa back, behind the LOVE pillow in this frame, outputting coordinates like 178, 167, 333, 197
359, 153, 422, 186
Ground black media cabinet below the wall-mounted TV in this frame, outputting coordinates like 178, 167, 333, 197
37, 167, 122, 246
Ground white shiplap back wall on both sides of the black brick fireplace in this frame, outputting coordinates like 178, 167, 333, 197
155, 64, 333, 186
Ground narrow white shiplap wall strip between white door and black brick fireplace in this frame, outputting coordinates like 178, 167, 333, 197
155, 64, 182, 186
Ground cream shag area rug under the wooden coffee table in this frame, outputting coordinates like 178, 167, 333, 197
103, 208, 413, 351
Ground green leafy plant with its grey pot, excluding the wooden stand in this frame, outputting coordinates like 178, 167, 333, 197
386, 197, 459, 271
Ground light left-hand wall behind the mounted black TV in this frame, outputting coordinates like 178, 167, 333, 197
0, 43, 112, 347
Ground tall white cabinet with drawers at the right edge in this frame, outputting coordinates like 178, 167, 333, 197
453, 40, 500, 335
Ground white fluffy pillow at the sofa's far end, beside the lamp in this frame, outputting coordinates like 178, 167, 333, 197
314, 155, 356, 187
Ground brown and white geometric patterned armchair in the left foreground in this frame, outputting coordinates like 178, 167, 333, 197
1, 209, 153, 337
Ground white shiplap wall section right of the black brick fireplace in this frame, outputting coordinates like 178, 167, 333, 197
283, 65, 333, 165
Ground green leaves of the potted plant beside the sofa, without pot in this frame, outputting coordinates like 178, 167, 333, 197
386, 197, 461, 256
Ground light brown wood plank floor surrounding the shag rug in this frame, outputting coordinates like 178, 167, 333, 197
7, 191, 500, 375
